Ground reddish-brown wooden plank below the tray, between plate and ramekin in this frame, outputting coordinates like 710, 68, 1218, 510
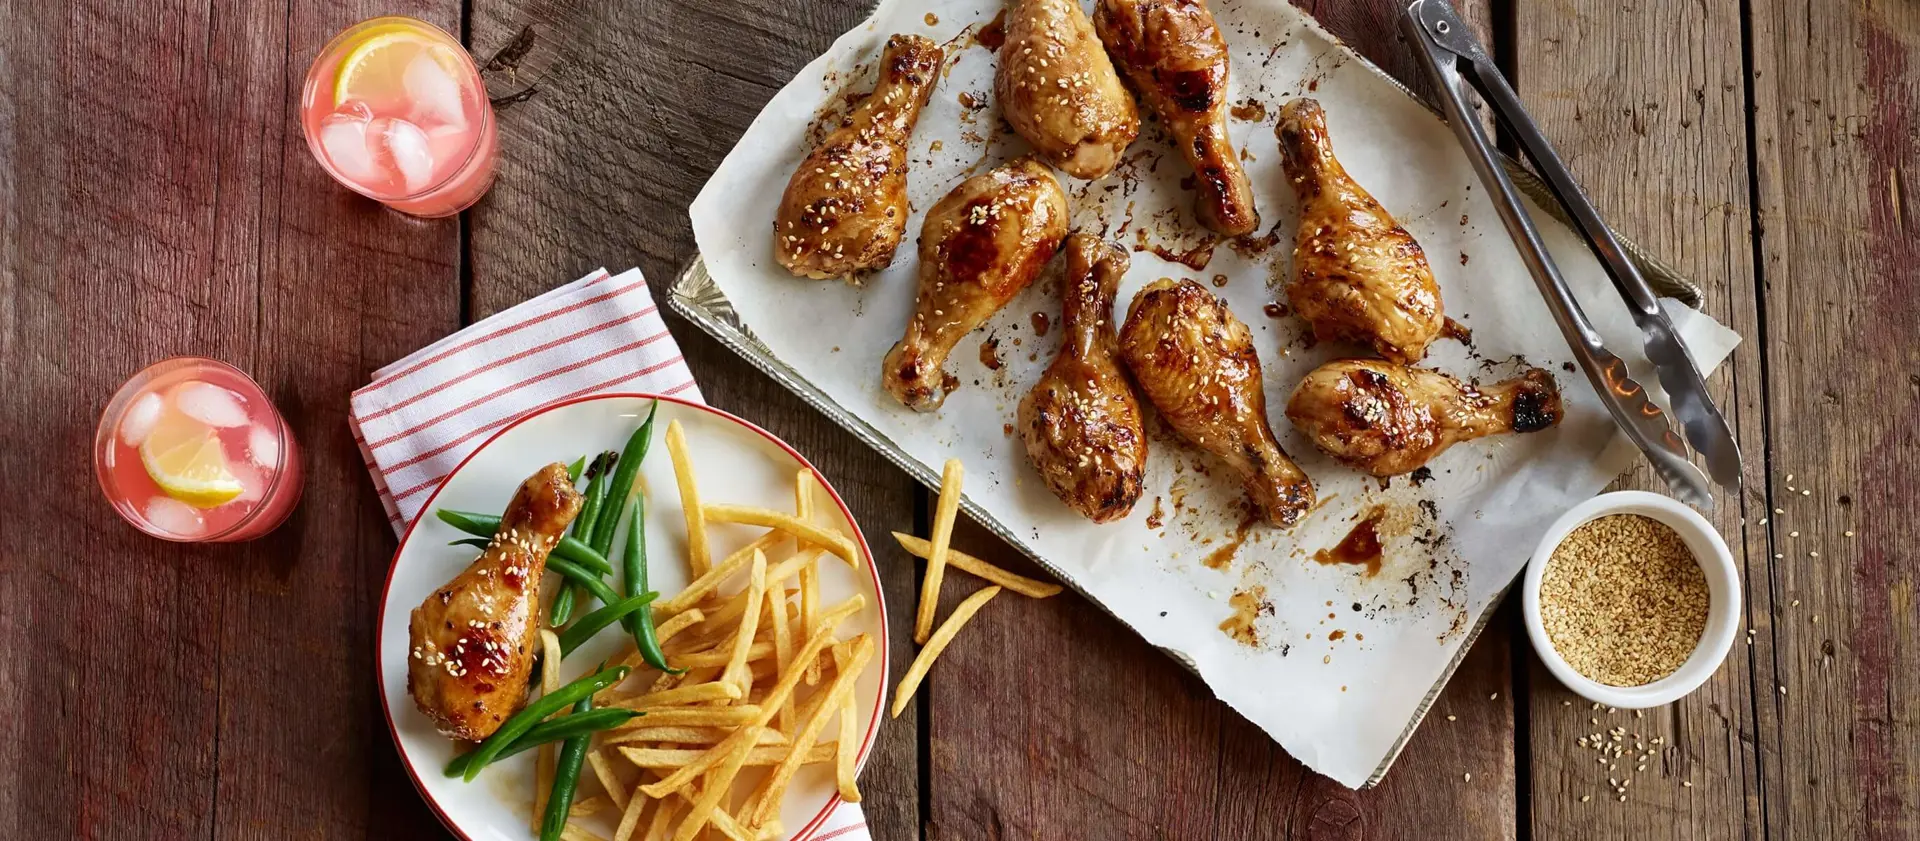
924, 0, 1517, 839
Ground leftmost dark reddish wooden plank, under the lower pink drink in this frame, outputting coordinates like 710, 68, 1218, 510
0, 2, 459, 839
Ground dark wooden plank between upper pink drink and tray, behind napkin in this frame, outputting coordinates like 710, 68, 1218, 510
468, 0, 920, 839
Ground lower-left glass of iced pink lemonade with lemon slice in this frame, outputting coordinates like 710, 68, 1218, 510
94, 357, 305, 543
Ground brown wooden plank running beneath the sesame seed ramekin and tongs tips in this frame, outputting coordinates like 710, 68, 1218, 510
1515, 0, 1766, 839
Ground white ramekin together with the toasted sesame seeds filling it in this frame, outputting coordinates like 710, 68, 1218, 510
1523, 492, 1740, 709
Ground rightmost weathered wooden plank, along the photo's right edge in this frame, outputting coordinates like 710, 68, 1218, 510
1749, 0, 1920, 839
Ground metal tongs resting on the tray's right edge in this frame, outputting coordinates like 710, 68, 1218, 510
1400, 0, 1740, 509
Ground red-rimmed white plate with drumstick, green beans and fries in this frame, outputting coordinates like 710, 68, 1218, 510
378, 394, 929, 841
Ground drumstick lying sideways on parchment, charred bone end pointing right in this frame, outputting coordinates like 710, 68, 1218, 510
1286, 359, 1561, 476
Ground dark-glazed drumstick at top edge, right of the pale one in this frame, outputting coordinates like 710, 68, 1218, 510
1092, 0, 1260, 236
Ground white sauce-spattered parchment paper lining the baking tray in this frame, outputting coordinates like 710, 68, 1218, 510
691, 0, 1738, 787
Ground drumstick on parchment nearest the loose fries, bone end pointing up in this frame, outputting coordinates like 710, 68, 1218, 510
1020, 234, 1146, 522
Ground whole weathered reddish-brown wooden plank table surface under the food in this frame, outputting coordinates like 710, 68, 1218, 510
0, 0, 1920, 841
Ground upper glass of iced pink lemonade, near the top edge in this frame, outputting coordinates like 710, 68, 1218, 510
300, 17, 499, 217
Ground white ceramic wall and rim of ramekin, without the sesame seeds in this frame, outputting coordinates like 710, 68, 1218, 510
1521, 492, 1740, 710
